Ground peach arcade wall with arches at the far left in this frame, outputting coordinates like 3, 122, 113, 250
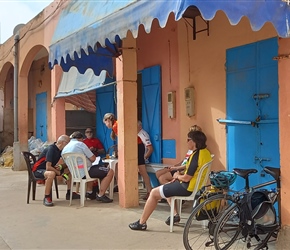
0, 0, 62, 170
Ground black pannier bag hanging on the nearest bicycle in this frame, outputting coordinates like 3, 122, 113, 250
240, 190, 278, 237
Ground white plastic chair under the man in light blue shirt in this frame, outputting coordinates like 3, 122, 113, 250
62, 153, 97, 207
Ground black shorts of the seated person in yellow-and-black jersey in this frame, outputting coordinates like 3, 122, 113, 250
160, 181, 192, 198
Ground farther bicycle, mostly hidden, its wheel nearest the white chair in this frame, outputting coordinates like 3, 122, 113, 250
183, 166, 276, 250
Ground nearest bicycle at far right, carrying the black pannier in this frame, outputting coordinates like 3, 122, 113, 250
213, 167, 281, 250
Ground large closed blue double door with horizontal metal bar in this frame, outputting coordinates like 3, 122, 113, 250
226, 38, 280, 189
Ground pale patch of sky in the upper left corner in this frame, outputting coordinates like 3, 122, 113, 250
0, 0, 53, 43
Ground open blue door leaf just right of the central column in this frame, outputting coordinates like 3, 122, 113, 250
141, 65, 161, 163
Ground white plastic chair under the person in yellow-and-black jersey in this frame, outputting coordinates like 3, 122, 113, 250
170, 160, 213, 232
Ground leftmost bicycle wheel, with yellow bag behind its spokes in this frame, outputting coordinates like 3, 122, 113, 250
183, 194, 231, 250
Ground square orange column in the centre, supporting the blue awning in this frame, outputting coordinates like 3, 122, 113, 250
116, 32, 139, 208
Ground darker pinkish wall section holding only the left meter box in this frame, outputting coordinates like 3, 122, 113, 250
137, 13, 181, 163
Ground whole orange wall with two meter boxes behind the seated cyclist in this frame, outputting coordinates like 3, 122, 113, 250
137, 12, 276, 172
